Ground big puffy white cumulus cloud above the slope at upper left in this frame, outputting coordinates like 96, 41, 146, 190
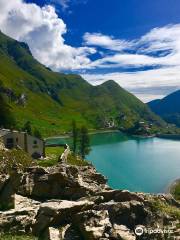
0, 0, 96, 70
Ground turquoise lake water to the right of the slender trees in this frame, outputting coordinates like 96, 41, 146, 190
47, 132, 180, 193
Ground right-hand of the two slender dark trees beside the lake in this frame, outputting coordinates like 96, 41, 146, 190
79, 126, 91, 159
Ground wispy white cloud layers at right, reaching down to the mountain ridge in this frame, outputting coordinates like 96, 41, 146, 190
83, 24, 180, 102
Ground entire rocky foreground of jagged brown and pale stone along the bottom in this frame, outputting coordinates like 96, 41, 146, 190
0, 164, 180, 240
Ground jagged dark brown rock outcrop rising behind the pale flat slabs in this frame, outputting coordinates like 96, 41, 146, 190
15, 164, 109, 200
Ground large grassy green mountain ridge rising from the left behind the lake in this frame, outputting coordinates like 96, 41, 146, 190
0, 32, 164, 135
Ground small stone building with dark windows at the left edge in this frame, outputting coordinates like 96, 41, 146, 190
0, 129, 45, 158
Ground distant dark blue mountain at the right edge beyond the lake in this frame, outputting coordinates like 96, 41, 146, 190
148, 90, 180, 127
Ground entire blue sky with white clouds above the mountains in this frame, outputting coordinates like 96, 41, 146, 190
0, 0, 180, 102
